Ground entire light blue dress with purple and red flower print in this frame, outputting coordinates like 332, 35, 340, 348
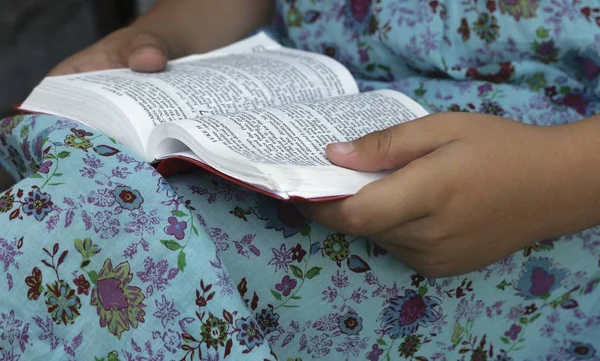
0, 0, 600, 361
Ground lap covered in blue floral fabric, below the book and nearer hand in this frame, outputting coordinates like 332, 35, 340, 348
0, 116, 600, 360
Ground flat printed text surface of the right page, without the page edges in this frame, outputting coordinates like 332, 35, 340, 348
169, 90, 427, 167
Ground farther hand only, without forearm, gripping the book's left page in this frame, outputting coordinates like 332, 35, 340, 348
49, 27, 168, 76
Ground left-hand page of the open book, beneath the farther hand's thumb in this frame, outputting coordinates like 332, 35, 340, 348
24, 31, 358, 150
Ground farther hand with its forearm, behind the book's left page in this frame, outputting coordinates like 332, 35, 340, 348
49, 0, 274, 75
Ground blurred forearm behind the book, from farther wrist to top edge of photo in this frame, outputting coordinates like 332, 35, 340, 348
131, 0, 273, 58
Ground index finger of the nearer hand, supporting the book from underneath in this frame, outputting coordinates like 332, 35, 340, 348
300, 153, 447, 236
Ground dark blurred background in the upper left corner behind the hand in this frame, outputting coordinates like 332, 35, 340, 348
0, 0, 153, 118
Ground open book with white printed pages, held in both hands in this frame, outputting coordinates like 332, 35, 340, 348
21, 33, 427, 200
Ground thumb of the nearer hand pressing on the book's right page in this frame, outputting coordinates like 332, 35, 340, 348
327, 116, 456, 172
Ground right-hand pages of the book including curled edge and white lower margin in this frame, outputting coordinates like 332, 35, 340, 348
148, 90, 427, 195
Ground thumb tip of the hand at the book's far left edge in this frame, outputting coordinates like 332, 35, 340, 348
122, 33, 169, 73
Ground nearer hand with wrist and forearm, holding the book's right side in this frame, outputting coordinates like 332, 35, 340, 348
300, 113, 600, 277
